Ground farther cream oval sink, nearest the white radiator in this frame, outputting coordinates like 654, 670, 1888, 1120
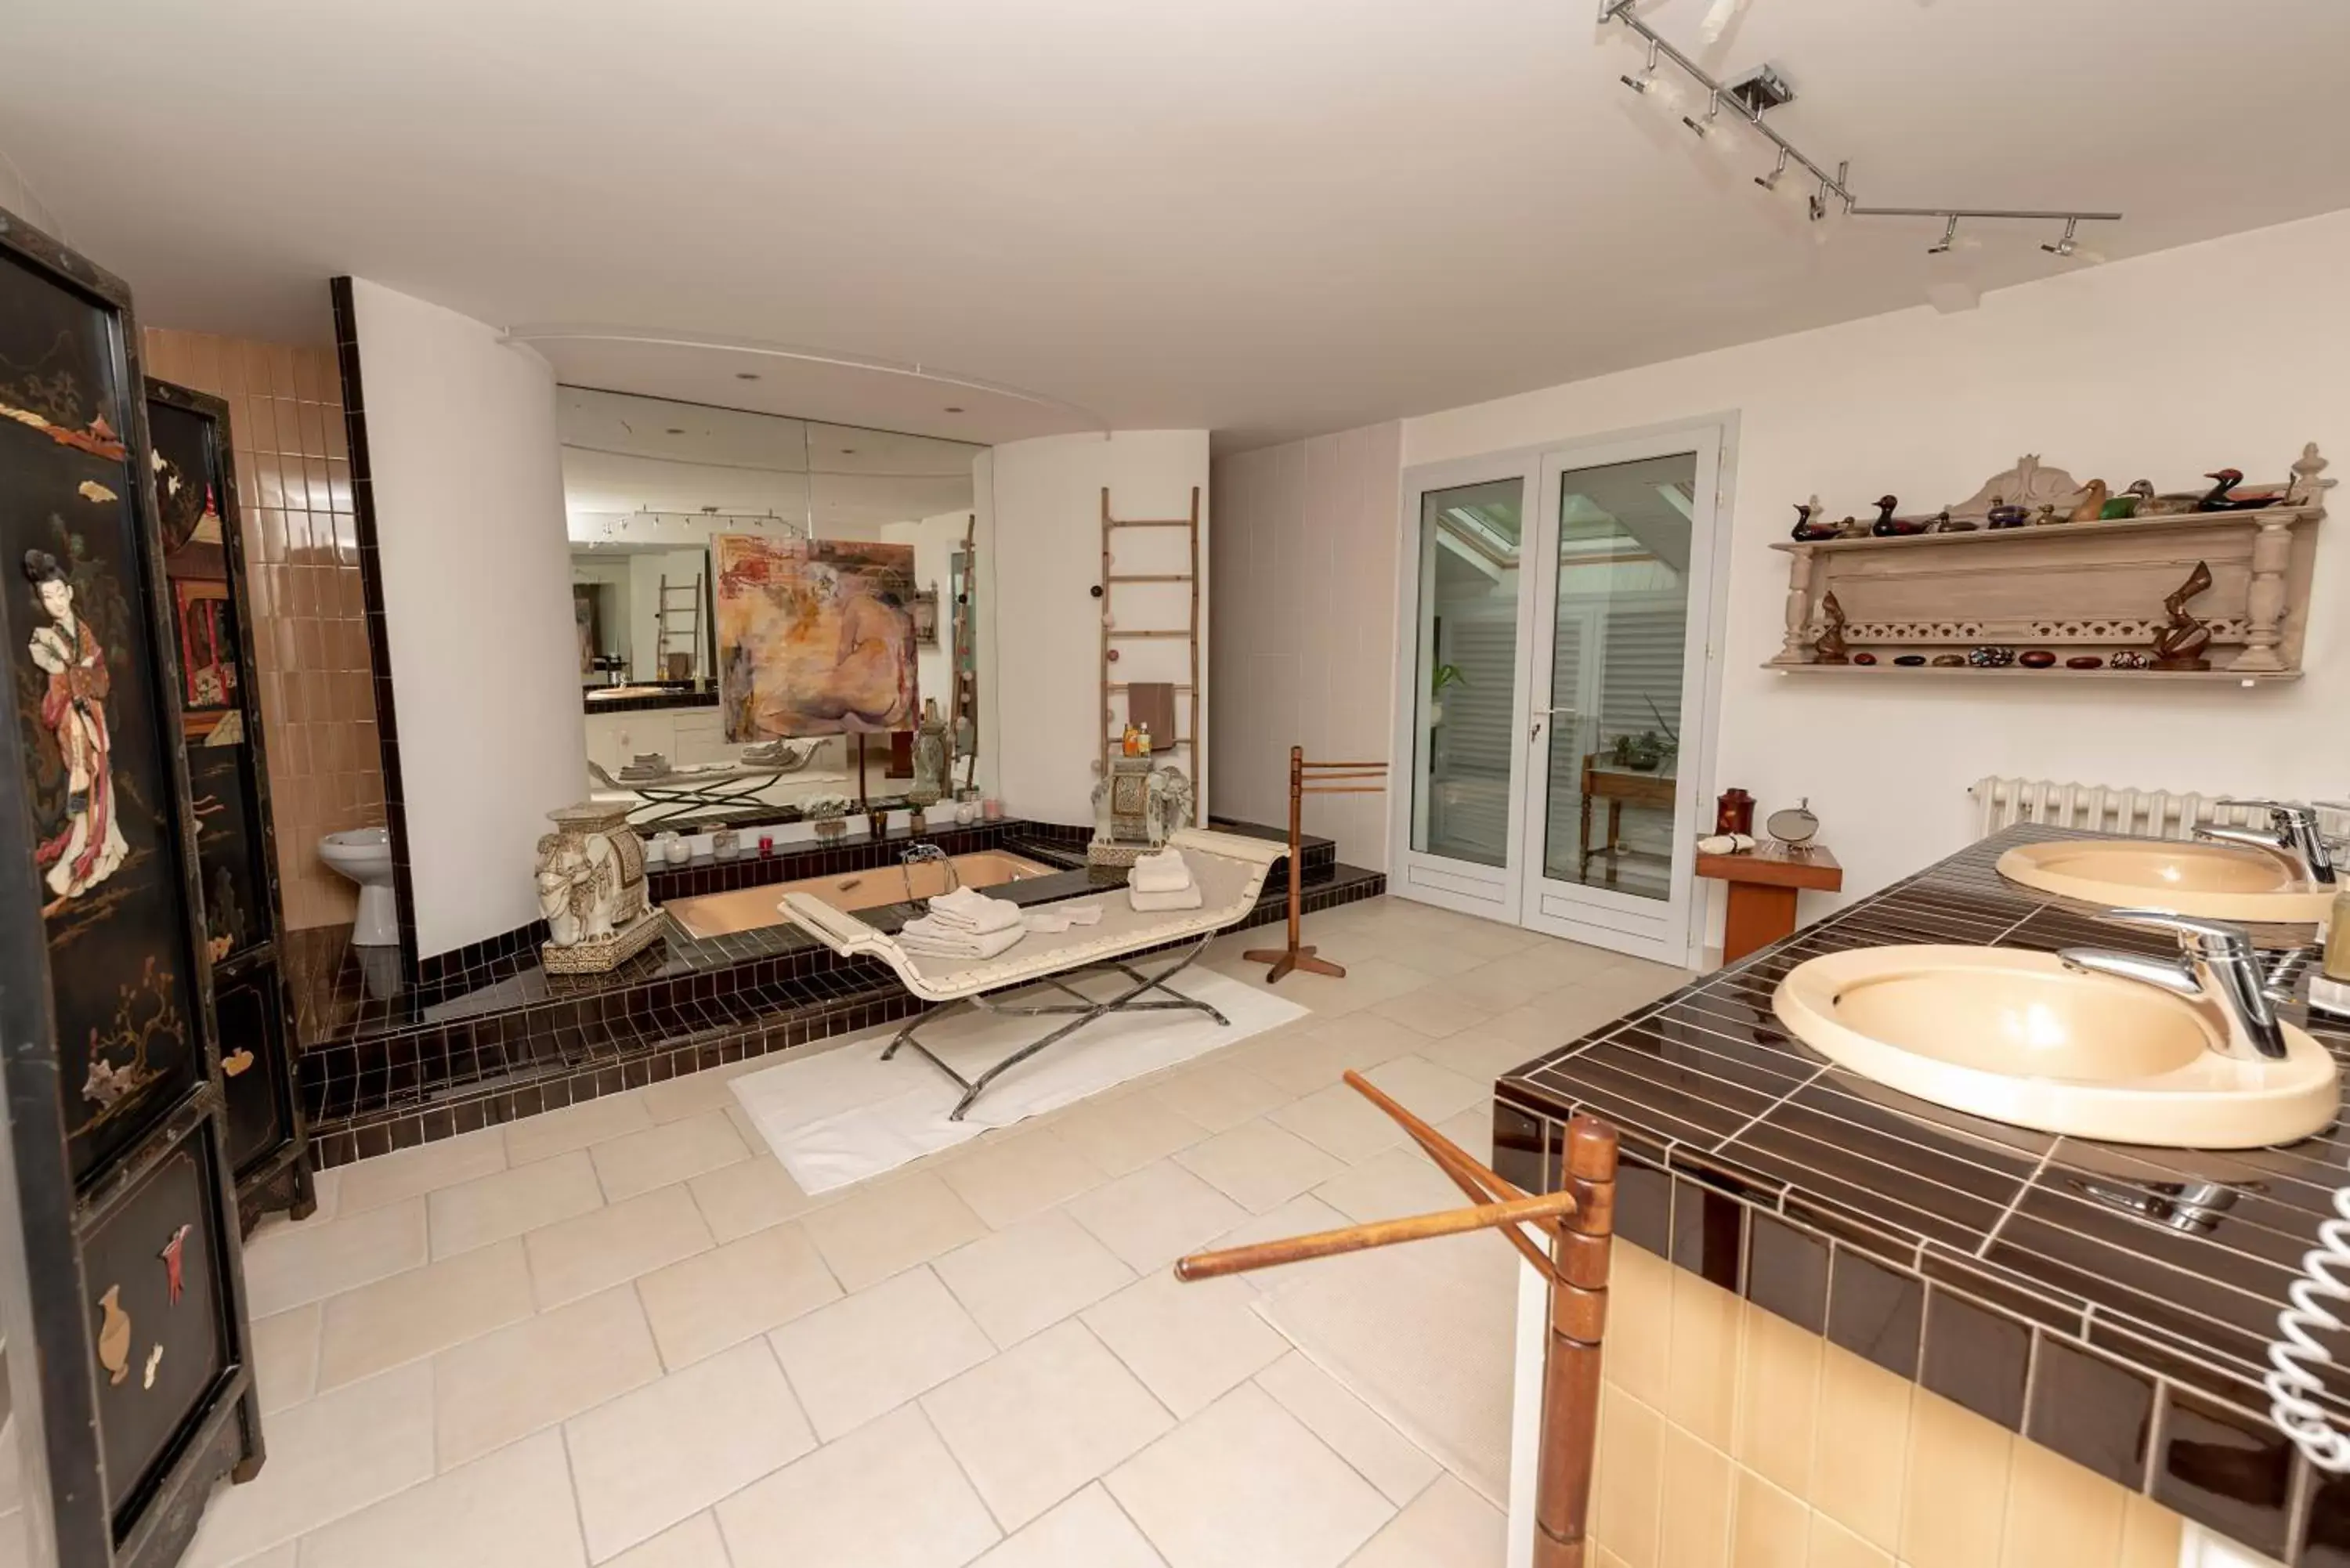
1998, 840, 2334, 922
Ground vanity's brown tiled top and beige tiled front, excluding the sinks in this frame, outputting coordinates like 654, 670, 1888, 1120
1495, 828, 2350, 1568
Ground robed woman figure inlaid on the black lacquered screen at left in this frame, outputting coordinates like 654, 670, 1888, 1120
24, 550, 129, 915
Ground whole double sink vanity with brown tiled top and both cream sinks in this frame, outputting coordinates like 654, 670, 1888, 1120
1495, 809, 2350, 1566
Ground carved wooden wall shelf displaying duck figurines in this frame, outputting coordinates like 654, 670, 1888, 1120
1767, 446, 2331, 686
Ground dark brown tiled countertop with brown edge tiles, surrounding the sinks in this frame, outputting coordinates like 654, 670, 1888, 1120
1495, 828, 2350, 1566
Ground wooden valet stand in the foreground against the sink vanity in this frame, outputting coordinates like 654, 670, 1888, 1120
1175, 1072, 1617, 1568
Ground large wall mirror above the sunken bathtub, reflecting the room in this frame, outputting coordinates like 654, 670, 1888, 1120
559, 385, 992, 833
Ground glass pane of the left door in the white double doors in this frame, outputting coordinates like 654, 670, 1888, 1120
1412, 477, 1525, 868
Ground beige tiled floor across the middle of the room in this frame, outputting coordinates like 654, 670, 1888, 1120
188, 898, 1680, 1568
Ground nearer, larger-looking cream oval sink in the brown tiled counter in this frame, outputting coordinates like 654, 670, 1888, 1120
1772, 945, 2341, 1150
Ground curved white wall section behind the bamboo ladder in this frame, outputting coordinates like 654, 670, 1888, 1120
975, 430, 1215, 823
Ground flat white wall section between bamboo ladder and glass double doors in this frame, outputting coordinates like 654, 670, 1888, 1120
1208, 423, 1403, 870
